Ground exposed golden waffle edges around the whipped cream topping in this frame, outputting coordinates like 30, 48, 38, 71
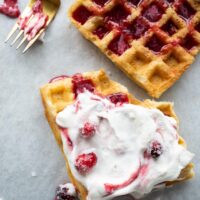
41, 70, 194, 200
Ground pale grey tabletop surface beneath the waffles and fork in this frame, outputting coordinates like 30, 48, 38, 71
0, 0, 200, 200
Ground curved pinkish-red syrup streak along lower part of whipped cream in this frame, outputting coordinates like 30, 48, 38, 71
104, 165, 148, 195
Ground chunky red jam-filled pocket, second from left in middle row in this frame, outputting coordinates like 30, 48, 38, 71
126, 17, 150, 39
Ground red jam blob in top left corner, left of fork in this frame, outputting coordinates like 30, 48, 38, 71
0, 0, 20, 18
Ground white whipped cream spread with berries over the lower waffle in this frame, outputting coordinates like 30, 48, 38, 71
56, 91, 193, 200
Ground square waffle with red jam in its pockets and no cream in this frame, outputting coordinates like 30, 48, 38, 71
69, 0, 200, 98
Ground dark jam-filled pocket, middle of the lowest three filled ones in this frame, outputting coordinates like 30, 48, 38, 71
146, 35, 164, 53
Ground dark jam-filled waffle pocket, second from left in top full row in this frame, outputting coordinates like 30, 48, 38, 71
104, 5, 130, 24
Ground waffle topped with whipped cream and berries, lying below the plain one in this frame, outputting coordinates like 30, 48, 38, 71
41, 70, 194, 200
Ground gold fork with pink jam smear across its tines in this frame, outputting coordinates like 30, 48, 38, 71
5, 0, 60, 53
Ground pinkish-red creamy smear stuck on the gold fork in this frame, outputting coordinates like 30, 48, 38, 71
18, 0, 48, 41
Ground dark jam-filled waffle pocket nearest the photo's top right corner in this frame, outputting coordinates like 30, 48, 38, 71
177, 1, 196, 20
